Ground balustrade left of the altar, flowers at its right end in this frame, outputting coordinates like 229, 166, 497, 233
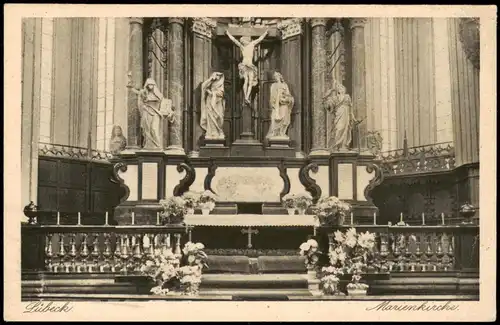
21, 225, 186, 274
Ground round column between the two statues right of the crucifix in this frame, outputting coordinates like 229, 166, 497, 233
309, 18, 330, 156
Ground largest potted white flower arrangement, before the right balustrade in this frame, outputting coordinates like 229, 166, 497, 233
328, 228, 375, 291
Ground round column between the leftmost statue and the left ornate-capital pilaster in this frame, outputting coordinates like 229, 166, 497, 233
167, 17, 185, 155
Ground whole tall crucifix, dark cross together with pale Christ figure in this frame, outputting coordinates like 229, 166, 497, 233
217, 18, 277, 140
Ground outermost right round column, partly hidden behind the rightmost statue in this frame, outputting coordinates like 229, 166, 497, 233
350, 18, 367, 150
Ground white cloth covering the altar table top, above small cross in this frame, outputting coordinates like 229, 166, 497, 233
184, 214, 319, 227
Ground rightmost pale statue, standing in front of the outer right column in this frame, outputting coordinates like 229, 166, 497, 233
324, 80, 358, 150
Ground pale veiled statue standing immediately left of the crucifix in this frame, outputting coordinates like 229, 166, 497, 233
200, 72, 226, 139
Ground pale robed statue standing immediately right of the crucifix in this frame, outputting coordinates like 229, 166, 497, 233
266, 72, 295, 139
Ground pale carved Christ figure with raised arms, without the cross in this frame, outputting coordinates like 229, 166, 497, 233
226, 30, 269, 104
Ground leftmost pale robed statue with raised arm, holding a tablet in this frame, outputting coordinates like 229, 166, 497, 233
127, 78, 174, 149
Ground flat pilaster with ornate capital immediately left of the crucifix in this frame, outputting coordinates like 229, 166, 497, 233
189, 18, 217, 157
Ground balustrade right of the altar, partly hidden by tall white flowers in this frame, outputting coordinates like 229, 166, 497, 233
318, 225, 479, 273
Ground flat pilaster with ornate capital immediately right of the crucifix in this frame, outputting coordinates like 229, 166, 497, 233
277, 19, 304, 158
